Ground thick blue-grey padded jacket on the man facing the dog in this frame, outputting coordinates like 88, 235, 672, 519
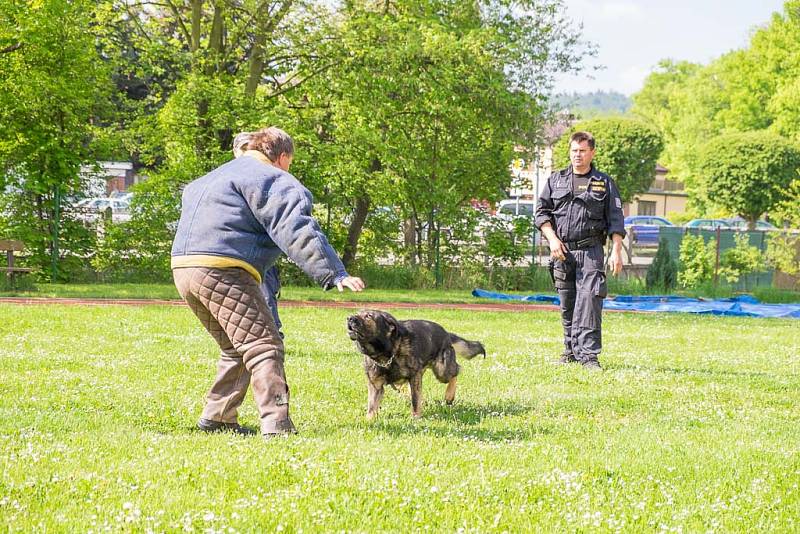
172, 155, 348, 289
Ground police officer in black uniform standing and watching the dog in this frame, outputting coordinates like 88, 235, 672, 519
535, 132, 625, 370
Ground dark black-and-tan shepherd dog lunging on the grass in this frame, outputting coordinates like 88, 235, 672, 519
347, 310, 486, 420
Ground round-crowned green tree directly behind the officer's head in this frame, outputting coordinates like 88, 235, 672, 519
553, 118, 664, 202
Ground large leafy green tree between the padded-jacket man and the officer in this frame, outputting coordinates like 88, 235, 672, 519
299, 0, 577, 264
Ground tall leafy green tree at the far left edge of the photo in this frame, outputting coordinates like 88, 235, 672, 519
0, 0, 110, 279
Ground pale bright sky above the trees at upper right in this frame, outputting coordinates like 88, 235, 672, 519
554, 0, 784, 95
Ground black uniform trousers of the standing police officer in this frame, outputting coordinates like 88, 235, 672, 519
553, 244, 608, 362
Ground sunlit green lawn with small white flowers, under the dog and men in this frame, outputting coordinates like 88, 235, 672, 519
0, 305, 800, 532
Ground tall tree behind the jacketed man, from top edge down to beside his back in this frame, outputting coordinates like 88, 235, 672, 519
96, 0, 327, 276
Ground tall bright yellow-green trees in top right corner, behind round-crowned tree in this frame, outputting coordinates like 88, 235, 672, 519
632, 0, 800, 216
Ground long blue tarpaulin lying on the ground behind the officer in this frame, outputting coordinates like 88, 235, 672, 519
472, 289, 800, 319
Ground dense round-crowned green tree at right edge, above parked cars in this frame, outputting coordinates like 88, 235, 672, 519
700, 131, 800, 230
